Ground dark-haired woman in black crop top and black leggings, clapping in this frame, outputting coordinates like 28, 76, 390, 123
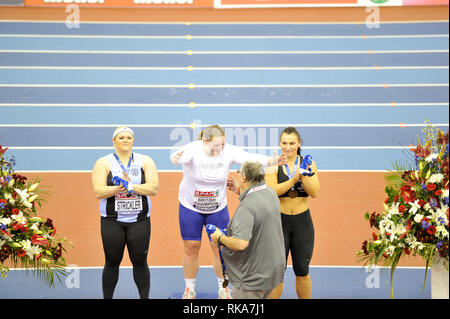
266, 127, 320, 299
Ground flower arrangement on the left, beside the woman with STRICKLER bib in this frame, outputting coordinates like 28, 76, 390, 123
0, 145, 70, 286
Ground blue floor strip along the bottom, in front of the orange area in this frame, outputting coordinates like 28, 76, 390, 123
0, 266, 431, 299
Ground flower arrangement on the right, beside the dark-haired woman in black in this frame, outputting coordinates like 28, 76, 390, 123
357, 122, 449, 298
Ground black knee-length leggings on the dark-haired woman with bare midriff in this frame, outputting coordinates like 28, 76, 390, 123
281, 209, 314, 277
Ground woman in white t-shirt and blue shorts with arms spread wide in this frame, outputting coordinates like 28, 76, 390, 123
170, 125, 286, 299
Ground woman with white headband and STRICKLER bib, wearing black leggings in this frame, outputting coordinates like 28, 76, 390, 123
92, 127, 159, 299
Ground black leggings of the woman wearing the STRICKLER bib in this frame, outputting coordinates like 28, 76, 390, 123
101, 217, 151, 299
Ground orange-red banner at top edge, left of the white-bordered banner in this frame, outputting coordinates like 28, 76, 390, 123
25, 0, 213, 8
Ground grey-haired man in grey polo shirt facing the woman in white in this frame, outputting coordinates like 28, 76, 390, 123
211, 162, 286, 299
